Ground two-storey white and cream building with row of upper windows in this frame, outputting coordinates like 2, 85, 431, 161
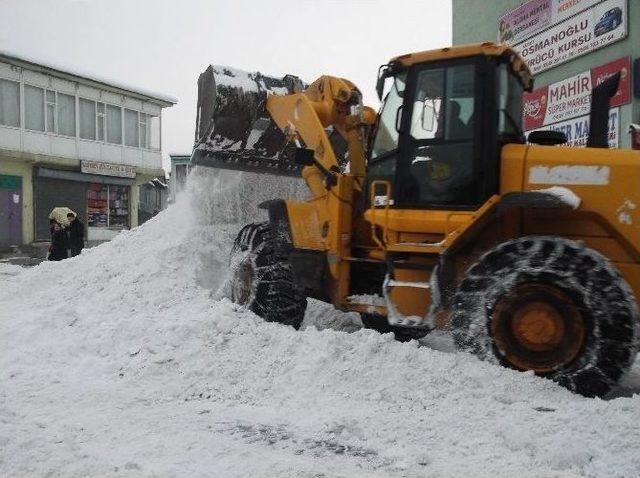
0, 53, 176, 248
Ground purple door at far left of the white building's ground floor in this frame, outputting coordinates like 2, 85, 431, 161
0, 174, 22, 249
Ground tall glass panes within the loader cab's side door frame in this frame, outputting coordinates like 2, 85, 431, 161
400, 62, 478, 206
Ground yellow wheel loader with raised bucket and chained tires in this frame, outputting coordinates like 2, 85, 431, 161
191, 43, 640, 396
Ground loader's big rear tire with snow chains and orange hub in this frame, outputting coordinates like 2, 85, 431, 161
452, 237, 640, 396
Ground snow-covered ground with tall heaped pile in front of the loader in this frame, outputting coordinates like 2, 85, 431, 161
0, 173, 640, 477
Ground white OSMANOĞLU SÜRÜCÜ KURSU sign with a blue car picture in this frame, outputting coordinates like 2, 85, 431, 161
514, 0, 627, 74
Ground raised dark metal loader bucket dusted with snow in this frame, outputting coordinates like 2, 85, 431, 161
191, 65, 305, 176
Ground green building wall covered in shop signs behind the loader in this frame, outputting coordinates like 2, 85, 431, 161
453, 0, 640, 148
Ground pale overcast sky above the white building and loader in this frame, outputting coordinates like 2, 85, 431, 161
0, 0, 451, 172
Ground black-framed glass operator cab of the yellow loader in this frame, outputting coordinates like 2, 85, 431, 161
368, 51, 525, 210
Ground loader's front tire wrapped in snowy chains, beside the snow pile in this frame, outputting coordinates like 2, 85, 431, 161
230, 223, 307, 329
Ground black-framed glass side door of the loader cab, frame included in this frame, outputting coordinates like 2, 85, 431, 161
395, 58, 488, 210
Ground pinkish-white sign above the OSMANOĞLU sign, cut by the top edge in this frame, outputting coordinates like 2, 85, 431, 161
498, 0, 602, 45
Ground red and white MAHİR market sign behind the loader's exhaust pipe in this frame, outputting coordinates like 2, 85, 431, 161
523, 57, 631, 131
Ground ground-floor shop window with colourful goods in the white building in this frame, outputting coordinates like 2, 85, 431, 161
87, 183, 129, 229
